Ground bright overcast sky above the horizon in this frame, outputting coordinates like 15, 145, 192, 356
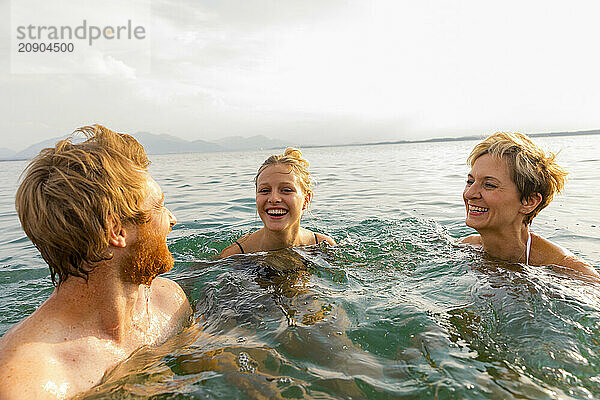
0, 0, 600, 150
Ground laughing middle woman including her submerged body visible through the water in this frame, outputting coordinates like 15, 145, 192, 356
220, 148, 382, 384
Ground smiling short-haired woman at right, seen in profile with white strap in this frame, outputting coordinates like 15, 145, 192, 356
462, 133, 600, 279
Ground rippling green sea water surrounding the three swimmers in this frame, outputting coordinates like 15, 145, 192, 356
0, 136, 600, 399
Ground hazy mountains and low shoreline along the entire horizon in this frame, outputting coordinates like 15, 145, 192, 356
0, 130, 600, 161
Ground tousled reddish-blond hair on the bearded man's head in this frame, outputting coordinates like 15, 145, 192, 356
15, 125, 150, 285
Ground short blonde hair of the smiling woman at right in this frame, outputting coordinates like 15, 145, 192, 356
467, 132, 567, 225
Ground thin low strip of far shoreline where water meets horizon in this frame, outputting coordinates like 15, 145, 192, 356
0, 130, 600, 162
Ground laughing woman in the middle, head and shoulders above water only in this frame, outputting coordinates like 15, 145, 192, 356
220, 147, 336, 258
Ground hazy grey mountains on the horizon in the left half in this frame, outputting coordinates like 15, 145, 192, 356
0, 132, 289, 161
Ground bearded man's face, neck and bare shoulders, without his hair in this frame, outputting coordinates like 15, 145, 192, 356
0, 175, 191, 399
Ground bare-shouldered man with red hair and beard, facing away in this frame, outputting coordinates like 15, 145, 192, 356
0, 125, 191, 399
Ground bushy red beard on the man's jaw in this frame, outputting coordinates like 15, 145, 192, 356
121, 227, 174, 285
